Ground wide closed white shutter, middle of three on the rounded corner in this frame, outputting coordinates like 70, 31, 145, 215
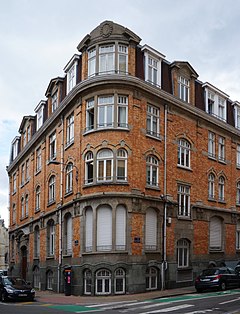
97, 206, 112, 251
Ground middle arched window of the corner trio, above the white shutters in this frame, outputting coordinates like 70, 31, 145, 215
97, 149, 113, 181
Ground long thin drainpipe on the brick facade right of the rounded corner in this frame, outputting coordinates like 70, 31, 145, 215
161, 104, 167, 290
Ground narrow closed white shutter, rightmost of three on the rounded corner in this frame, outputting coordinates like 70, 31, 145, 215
116, 205, 126, 250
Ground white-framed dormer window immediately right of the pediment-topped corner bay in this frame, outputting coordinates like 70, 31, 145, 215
142, 45, 165, 87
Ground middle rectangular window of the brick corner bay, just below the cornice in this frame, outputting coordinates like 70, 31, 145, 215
98, 96, 114, 128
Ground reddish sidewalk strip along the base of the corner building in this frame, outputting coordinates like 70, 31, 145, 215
36, 286, 196, 305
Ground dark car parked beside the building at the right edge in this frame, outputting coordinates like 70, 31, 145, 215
195, 267, 240, 292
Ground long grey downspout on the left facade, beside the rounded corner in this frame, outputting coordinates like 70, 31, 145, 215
58, 116, 64, 293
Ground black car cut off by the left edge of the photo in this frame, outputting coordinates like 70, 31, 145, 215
0, 276, 35, 302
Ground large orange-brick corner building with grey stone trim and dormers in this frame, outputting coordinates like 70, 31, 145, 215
7, 21, 240, 295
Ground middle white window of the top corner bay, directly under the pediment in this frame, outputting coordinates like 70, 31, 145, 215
99, 45, 115, 74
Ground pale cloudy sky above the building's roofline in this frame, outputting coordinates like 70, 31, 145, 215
0, 0, 240, 226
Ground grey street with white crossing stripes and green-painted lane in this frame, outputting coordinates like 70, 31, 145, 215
0, 289, 240, 314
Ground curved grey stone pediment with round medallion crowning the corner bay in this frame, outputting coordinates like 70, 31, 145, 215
77, 21, 141, 52
